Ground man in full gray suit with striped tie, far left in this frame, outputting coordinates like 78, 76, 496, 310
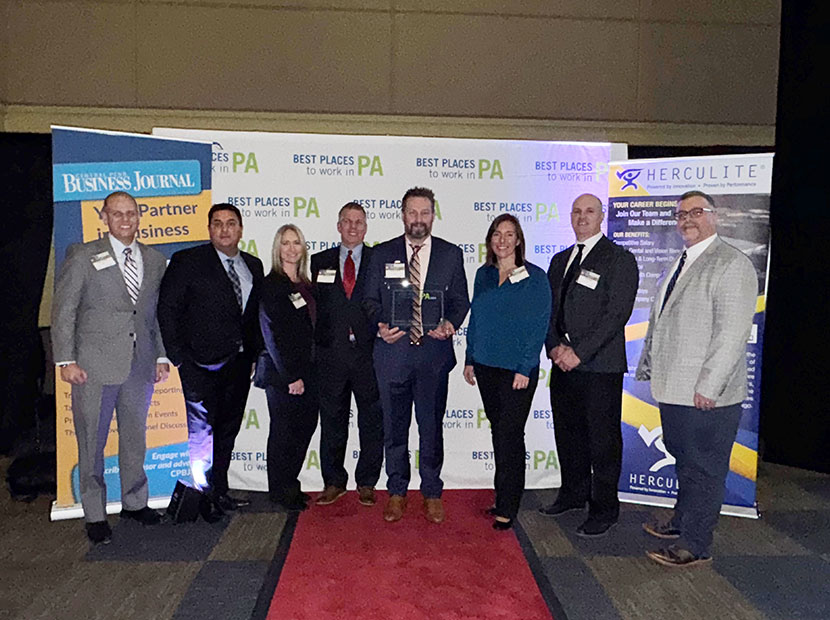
52, 192, 170, 544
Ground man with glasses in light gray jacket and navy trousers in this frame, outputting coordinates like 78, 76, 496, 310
636, 191, 758, 566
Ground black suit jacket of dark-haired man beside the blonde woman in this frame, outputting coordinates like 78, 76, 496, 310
158, 243, 263, 366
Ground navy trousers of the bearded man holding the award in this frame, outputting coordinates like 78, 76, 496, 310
375, 345, 449, 499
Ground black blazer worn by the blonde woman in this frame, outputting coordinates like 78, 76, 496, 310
254, 271, 314, 387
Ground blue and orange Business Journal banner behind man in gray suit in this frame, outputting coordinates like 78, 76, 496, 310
52, 127, 211, 519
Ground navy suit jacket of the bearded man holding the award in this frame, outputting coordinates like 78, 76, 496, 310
361, 235, 470, 372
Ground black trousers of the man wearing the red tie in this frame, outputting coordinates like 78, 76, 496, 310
317, 347, 383, 489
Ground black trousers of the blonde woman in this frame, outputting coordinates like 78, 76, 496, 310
265, 379, 318, 502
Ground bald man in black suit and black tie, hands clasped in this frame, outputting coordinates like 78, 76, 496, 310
540, 194, 639, 538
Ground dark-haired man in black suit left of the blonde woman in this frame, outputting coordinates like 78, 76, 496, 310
158, 203, 263, 518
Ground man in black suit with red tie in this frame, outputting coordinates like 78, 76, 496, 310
311, 202, 383, 506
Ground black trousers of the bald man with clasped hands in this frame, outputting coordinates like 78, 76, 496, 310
550, 365, 623, 522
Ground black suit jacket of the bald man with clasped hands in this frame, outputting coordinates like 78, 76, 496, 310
545, 235, 640, 372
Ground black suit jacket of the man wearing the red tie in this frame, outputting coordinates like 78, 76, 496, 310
311, 244, 378, 352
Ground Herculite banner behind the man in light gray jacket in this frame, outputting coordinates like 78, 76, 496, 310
608, 154, 773, 517
